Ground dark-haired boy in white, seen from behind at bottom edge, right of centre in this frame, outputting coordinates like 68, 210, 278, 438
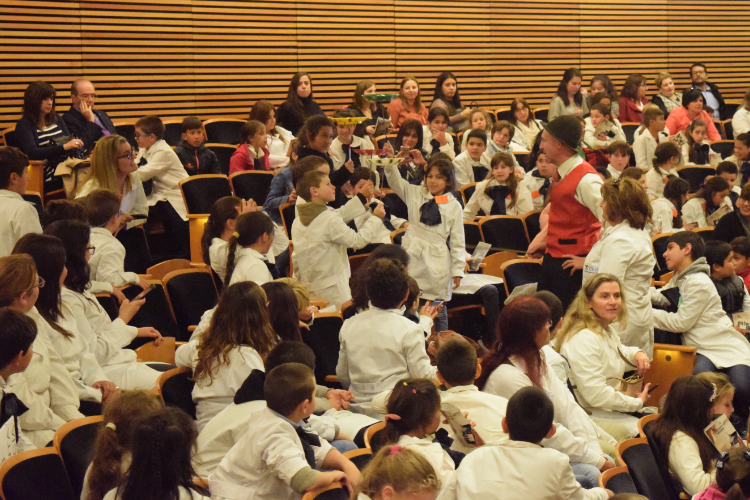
455, 387, 612, 500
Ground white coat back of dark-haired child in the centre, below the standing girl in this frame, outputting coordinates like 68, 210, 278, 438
336, 307, 437, 404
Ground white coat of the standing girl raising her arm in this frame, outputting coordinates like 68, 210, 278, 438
385, 165, 466, 301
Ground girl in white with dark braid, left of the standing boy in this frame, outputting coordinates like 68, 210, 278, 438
224, 212, 279, 286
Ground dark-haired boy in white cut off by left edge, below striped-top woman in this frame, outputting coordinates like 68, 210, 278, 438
0, 146, 42, 257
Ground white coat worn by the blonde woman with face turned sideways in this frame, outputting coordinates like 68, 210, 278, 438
560, 326, 643, 412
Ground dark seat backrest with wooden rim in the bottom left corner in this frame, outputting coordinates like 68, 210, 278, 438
0, 448, 80, 500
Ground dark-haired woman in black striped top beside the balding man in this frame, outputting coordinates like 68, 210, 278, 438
14, 81, 83, 192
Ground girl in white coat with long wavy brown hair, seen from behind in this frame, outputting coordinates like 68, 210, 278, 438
175, 281, 276, 429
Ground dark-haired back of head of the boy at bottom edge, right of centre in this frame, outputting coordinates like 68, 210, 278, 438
505, 387, 555, 444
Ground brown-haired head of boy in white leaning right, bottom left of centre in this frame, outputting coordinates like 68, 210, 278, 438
263, 363, 315, 418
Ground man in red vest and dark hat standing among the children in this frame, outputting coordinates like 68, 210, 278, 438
538, 115, 602, 309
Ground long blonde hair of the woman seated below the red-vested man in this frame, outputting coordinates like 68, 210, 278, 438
554, 273, 628, 351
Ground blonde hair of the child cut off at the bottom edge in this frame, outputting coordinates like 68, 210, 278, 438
351, 445, 440, 500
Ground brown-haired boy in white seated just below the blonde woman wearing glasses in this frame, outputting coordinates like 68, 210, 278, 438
85, 189, 148, 289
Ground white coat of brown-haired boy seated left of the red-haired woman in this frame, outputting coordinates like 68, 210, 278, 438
440, 385, 509, 454
